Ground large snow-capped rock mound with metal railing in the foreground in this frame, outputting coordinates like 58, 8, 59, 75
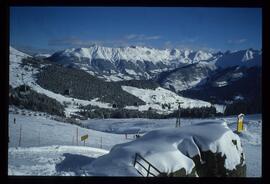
84, 121, 245, 176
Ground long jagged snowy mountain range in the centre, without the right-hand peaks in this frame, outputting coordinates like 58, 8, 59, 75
49, 45, 214, 81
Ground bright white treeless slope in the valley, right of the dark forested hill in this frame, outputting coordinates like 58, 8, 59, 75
122, 86, 211, 113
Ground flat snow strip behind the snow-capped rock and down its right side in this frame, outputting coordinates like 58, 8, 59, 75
83, 115, 262, 177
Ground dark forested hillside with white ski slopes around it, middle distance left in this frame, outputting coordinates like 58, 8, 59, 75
9, 47, 214, 116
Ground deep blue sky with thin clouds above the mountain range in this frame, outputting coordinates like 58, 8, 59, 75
10, 7, 262, 51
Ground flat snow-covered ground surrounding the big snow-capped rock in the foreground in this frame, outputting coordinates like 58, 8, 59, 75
8, 110, 262, 177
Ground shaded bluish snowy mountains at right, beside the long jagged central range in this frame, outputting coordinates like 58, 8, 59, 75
157, 49, 262, 92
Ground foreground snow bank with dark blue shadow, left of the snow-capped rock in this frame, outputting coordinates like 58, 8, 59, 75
8, 146, 108, 176
